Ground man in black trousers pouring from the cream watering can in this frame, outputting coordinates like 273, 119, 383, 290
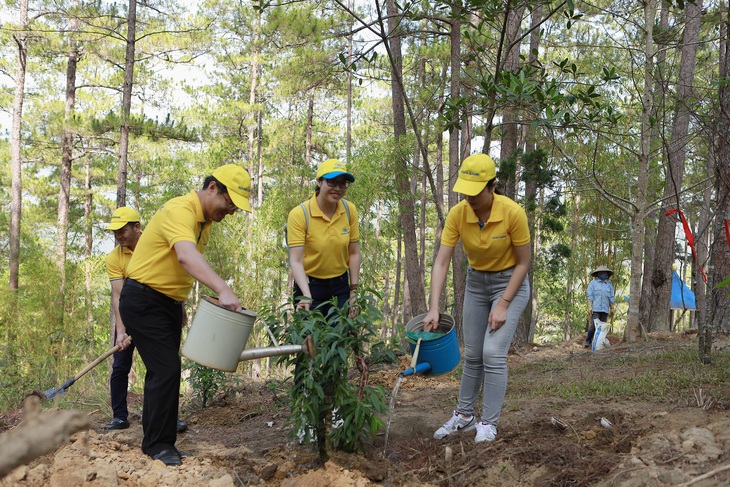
119, 164, 251, 466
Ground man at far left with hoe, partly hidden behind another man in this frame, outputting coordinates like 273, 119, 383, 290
104, 206, 188, 433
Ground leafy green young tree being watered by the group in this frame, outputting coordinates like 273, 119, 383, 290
260, 294, 386, 459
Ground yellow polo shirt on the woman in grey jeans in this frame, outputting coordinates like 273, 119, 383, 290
441, 194, 530, 272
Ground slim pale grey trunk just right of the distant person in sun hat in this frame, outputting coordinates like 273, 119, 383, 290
624, 0, 657, 342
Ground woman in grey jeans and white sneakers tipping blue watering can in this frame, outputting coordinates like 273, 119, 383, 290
423, 154, 532, 443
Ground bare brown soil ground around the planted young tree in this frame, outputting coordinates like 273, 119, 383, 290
0, 337, 730, 487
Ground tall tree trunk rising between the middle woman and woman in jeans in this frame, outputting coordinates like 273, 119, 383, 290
386, 0, 426, 312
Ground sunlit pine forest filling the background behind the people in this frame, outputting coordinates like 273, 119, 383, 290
0, 0, 730, 416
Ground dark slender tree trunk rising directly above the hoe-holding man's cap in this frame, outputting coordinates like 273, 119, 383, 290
117, 0, 137, 207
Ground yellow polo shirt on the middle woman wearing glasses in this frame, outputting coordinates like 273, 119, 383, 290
286, 196, 360, 279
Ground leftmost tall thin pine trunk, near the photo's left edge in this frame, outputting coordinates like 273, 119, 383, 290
9, 0, 28, 291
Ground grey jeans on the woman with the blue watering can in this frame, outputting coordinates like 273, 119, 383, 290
456, 267, 530, 425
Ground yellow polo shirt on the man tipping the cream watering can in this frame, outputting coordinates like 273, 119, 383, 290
128, 191, 213, 301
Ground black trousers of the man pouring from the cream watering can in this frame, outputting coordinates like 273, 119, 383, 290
119, 279, 183, 456
